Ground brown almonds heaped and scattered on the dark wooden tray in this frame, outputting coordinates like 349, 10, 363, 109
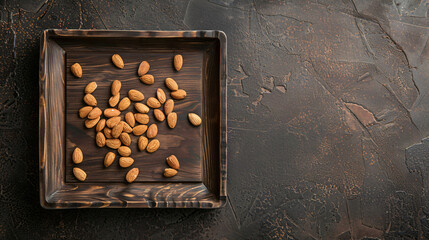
71, 54, 201, 183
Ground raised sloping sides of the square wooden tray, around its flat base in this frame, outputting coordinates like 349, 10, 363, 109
39, 29, 227, 209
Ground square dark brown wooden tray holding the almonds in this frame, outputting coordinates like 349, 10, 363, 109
39, 30, 226, 208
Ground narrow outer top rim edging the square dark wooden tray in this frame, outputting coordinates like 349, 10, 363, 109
39, 29, 227, 209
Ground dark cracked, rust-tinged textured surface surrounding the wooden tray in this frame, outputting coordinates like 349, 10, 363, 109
0, 0, 429, 239
